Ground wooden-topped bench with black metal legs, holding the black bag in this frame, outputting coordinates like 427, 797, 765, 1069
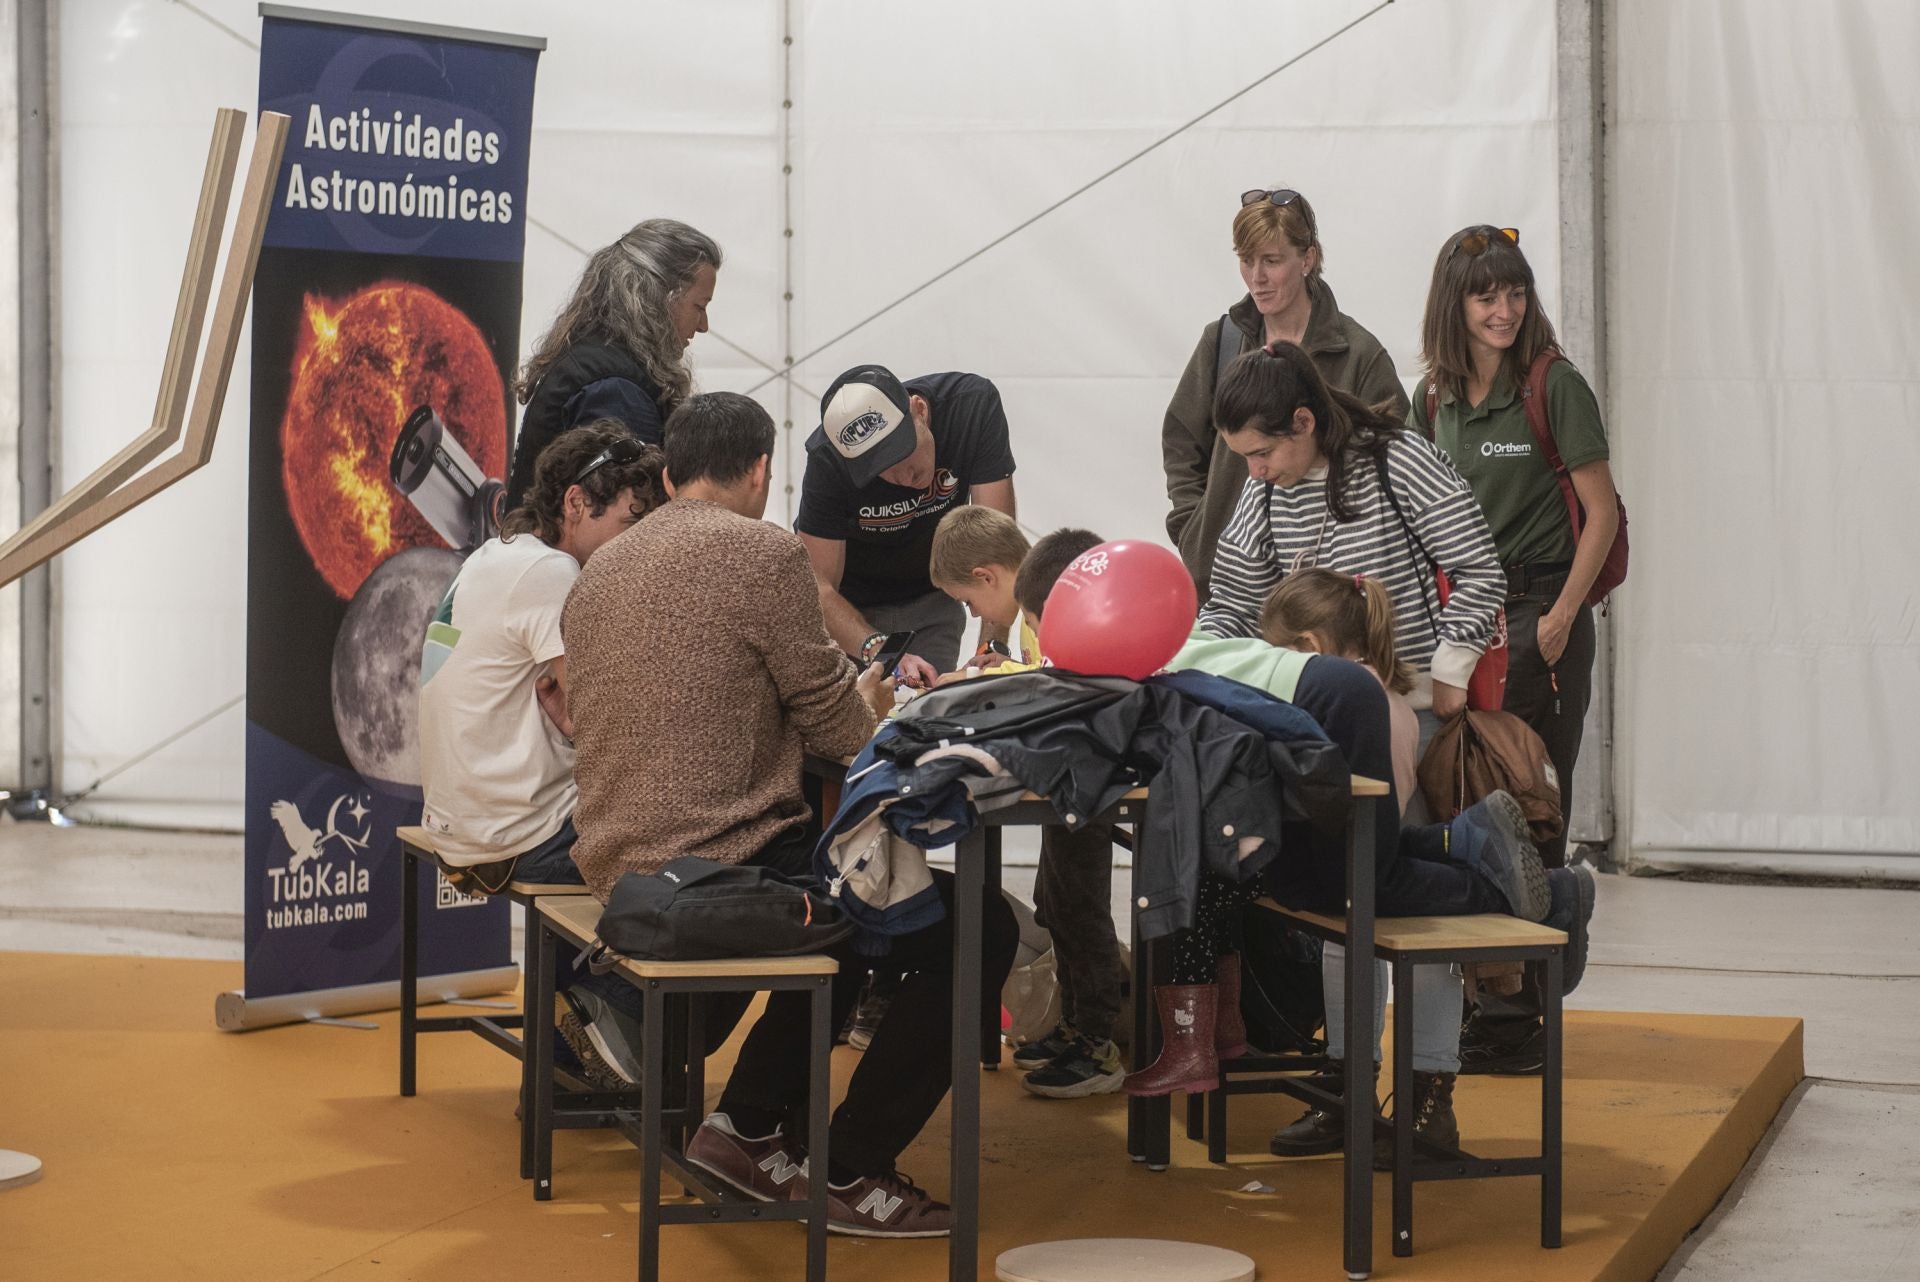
526, 898, 839, 1282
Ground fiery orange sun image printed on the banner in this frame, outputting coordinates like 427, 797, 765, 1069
280, 280, 507, 602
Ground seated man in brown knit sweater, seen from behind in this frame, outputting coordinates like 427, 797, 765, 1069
561, 392, 1018, 1238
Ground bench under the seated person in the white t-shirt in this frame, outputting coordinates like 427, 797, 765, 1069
397, 827, 620, 1180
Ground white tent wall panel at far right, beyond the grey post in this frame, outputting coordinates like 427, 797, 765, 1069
1609, 0, 1920, 877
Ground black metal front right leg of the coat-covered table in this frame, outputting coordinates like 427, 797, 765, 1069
1342, 796, 1375, 1280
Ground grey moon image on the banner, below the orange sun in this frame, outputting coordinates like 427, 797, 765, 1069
334, 547, 461, 789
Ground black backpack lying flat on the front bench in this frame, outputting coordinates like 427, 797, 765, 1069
591, 854, 852, 973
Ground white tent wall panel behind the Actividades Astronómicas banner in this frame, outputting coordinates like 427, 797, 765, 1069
52, 0, 781, 827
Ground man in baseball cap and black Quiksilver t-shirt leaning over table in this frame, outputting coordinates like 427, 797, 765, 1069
793, 365, 1014, 685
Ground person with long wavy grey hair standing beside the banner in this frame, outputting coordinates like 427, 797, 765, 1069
507, 219, 720, 510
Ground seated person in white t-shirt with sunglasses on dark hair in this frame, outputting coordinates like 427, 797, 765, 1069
420, 418, 664, 1080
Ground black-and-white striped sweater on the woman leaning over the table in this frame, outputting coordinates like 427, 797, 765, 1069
1200, 432, 1507, 708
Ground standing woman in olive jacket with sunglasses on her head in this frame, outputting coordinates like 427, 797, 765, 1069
1160, 188, 1407, 601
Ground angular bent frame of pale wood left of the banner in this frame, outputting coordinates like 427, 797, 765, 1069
0, 107, 288, 587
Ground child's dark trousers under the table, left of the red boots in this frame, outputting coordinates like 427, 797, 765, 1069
1033, 823, 1123, 1042
